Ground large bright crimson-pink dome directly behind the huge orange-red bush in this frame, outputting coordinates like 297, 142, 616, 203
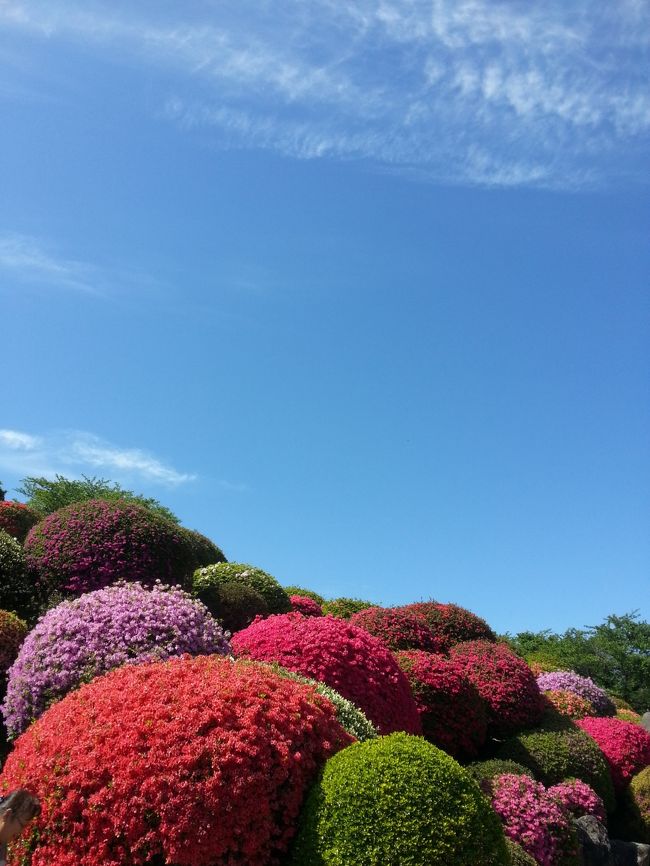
232, 613, 421, 734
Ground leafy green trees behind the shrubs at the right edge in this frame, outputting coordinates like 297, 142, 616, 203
506, 611, 650, 713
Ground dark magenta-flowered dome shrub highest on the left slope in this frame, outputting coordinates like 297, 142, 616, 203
25, 499, 192, 595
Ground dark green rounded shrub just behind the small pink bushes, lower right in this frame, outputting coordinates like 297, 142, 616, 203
498, 728, 615, 812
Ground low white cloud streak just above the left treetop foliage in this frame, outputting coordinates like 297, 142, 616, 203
0, 429, 197, 486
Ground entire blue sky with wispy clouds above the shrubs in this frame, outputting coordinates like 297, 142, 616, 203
0, 0, 650, 632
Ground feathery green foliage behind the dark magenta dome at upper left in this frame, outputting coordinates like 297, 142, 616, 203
16, 475, 180, 524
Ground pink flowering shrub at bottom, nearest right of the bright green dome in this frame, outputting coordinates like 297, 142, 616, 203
492, 773, 578, 866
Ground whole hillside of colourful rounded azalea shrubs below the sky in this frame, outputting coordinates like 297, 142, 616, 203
0, 476, 650, 866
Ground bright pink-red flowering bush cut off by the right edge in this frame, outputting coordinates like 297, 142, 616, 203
576, 718, 650, 791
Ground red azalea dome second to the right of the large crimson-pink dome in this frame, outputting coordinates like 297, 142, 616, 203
450, 640, 544, 735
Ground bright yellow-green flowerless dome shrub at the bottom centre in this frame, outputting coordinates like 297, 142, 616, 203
290, 734, 509, 866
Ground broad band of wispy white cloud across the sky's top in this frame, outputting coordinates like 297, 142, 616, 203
0, 0, 650, 188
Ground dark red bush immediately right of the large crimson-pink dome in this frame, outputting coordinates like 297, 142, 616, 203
395, 650, 487, 758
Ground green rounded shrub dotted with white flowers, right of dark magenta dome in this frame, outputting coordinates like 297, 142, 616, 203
193, 562, 291, 616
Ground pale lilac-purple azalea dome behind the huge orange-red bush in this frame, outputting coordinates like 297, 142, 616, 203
2, 581, 231, 738
